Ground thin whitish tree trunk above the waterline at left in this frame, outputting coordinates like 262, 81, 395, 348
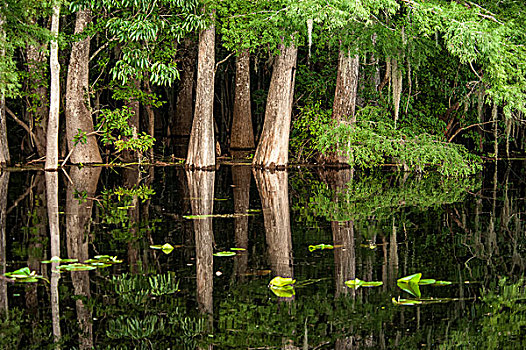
45, 5, 61, 170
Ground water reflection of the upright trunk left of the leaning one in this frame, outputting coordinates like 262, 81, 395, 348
186, 170, 215, 315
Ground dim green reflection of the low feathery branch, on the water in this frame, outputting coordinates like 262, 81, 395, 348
306, 175, 476, 221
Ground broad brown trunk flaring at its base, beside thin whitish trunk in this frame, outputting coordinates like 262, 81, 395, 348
66, 9, 102, 164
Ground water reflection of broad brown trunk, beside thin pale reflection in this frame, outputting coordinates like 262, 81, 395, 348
66, 167, 101, 349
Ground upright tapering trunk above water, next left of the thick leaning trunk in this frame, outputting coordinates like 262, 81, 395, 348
186, 20, 216, 169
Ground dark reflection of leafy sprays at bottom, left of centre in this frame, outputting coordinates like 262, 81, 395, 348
96, 273, 204, 349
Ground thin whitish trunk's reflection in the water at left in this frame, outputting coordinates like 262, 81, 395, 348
45, 171, 62, 342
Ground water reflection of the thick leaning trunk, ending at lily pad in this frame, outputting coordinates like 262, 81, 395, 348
254, 170, 294, 292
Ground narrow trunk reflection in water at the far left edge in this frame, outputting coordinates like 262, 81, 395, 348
0, 172, 9, 315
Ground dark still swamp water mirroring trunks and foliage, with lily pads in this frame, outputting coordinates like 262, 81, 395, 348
0, 164, 526, 350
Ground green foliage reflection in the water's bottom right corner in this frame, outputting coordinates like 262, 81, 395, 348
444, 279, 526, 349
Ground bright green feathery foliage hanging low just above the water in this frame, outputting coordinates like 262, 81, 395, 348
316, 108, 481, 176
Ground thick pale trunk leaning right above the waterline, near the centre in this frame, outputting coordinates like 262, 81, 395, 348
253, 45, 298, 168
